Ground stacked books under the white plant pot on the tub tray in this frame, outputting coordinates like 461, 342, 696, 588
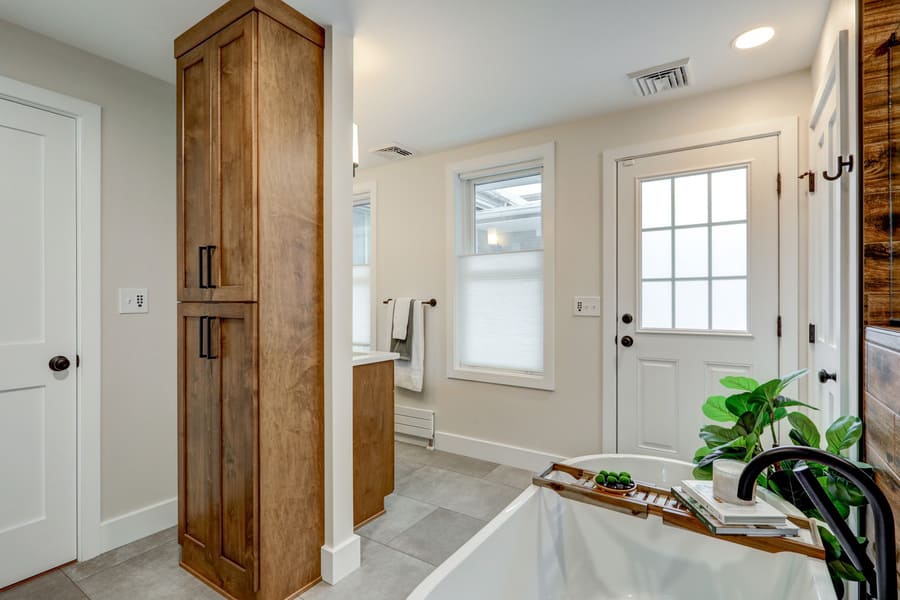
672, 479, 799, 537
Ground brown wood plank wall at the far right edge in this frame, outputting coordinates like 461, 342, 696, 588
860, 0, 900, 580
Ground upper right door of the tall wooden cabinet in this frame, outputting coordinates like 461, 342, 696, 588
206, 12, 258, 302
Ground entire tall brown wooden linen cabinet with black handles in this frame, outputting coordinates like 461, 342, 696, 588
175, 0, 324, 600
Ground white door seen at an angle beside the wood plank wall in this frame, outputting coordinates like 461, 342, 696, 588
808, 32, 852, 430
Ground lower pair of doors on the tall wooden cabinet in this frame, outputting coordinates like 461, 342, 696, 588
178, 303, 259, 598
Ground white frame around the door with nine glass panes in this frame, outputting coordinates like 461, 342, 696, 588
600, 116, 806, 453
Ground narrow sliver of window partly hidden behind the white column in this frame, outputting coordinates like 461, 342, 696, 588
353, 192, 375, 350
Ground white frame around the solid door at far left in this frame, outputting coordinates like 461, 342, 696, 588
0, 76, 101, 560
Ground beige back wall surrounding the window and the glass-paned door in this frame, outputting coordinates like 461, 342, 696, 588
356, 72, 812, 456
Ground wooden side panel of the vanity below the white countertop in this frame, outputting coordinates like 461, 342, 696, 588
353, 360, 394, 527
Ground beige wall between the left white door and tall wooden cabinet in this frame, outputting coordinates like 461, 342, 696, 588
0, 21, 177, 520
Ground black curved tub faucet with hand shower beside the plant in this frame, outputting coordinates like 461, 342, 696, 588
738, 446, 897, 600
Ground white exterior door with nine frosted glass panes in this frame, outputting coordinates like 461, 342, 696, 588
617, 135, 779, 461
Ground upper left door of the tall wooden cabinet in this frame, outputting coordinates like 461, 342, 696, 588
177, 44, 213, 301
